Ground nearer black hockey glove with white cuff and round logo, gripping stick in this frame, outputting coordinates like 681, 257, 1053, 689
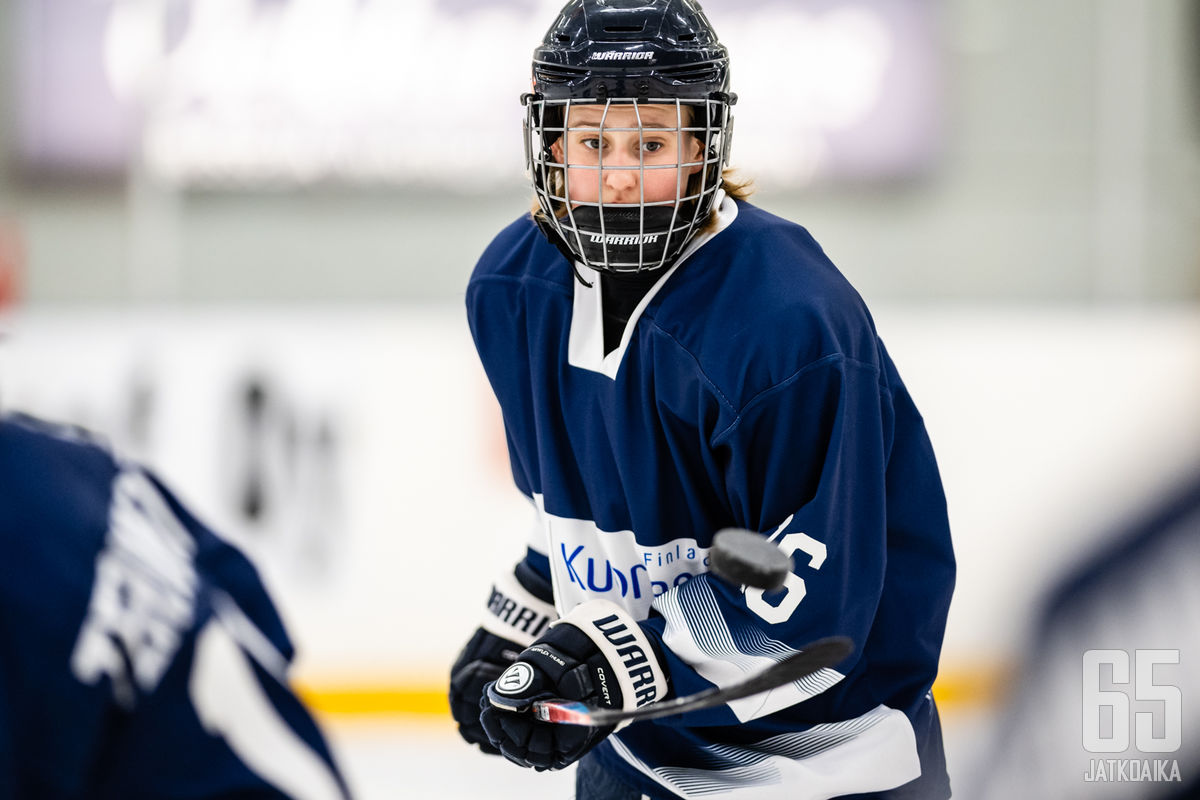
480, 600, 668, 770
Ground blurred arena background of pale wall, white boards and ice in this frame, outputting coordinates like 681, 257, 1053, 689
0, 0, 1200, 798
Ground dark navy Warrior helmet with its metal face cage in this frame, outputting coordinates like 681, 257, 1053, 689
522, 0, 737, 272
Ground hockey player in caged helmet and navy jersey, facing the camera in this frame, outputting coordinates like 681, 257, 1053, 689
450, 0, 954, 800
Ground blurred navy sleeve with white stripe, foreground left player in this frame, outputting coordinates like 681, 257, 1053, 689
94, 590, 349, 800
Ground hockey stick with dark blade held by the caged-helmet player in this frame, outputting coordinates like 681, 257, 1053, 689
533, 636, 854, 727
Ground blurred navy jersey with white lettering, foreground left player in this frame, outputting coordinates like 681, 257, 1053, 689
0, 416, 347, 800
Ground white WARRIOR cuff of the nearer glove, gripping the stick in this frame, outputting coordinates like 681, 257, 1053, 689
554, 600, 667, 710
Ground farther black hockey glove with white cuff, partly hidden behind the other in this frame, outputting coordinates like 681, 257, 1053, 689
450, 561, 558, 756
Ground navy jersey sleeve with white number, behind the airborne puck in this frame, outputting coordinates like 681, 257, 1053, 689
643, 356, 921, 727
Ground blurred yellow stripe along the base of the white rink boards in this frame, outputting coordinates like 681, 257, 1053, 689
296, 667, 1010, 716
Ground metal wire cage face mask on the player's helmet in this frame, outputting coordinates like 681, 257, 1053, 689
522, 92, 736, 272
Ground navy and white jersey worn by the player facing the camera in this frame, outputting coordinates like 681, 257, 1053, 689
467, 198, 954, 799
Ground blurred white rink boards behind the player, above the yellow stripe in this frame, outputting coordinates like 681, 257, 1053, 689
0, 306, 1200, 682
